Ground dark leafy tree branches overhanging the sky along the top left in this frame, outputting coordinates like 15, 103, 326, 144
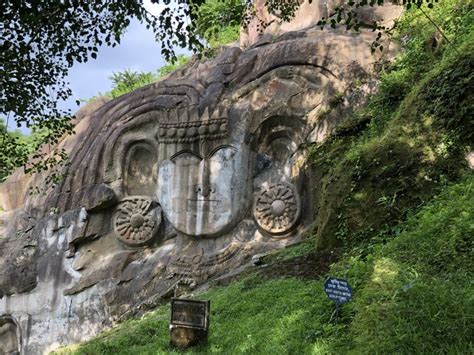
0, 0, 437, 184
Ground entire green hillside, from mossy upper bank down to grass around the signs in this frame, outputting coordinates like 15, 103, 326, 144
56, 0, 474, 354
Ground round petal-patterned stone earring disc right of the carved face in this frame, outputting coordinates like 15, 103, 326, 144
254, 183, 301, 234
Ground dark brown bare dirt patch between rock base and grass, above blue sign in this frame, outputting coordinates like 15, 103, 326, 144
259, 250, 339, 279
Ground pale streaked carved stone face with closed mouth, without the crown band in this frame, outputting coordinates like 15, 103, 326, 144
158, 145, 248, 237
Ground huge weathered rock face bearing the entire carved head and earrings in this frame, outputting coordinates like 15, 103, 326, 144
0, 1, 404, 354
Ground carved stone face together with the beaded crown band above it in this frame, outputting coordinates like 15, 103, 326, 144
157, 107, 249, 237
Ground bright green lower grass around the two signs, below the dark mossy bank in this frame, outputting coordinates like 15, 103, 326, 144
56, 175, 474, 354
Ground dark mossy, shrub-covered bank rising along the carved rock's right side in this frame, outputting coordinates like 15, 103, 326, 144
311, 0, 474, 252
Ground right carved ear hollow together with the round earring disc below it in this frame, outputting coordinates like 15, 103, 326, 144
253, 116, 305, 237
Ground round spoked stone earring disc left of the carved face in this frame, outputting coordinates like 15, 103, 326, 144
114, 196, 161, 246
